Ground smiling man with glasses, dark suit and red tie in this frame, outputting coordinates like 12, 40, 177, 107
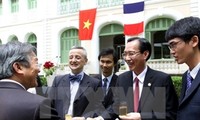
113, 37, 178, 120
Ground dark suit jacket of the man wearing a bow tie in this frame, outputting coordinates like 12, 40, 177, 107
49, 74, 100, 118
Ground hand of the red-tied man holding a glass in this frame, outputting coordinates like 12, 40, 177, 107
119, 112, 141, 120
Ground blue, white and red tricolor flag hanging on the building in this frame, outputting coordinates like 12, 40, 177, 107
123, 0, 144, 36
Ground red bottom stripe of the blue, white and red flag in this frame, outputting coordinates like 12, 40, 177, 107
124, 21, 144, 35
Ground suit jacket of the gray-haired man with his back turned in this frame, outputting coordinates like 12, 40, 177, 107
0, 81, 60, 120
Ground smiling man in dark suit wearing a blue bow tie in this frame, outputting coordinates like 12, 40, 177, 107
49, 47, 101, 119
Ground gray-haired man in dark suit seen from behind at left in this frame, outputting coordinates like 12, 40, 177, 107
0, 41, 60, 120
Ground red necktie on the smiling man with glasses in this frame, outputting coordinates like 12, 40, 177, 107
134, 77, 139, 112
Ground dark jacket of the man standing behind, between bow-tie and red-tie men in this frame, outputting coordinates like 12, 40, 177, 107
94, 74, 118, 109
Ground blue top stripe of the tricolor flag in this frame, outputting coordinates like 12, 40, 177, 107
123, 1, 144, 14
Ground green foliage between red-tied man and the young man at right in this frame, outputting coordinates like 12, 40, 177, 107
172, 76, 182, 97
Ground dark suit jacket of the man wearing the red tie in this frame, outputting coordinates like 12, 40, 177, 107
111, 67, 178, 120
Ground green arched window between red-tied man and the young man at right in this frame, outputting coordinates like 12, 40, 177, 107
145, 18, 175, 59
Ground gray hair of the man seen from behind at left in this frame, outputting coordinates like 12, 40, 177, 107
0, 41, 36, 79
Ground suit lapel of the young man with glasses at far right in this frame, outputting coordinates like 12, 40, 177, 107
180, 70, 200, 105
